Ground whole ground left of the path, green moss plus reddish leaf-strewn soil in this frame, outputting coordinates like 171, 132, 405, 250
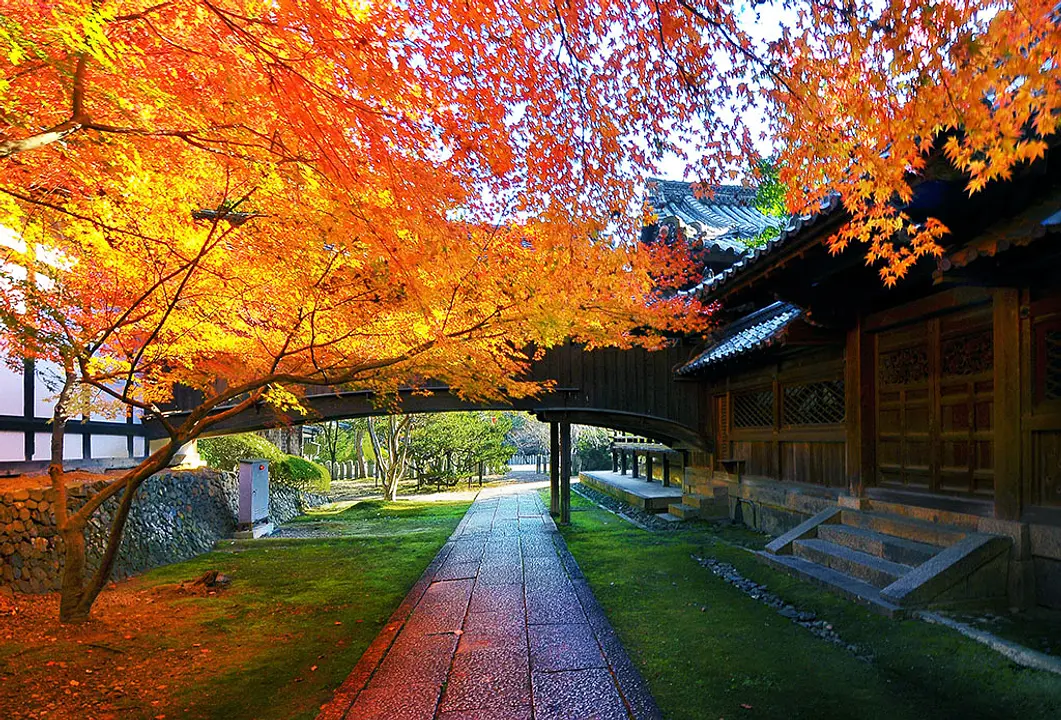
0, 501, 469, 720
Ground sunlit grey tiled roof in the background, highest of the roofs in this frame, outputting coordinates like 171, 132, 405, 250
648, 178, 784, 256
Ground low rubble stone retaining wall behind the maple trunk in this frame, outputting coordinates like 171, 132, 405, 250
0, 470, 324, 593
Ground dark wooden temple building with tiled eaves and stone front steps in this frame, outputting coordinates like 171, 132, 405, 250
636, 147, 1061, 611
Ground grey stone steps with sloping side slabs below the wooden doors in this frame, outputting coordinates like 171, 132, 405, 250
759, 498, 1012, 617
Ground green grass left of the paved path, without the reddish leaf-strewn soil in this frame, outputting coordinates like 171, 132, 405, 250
139, 502, 469, 720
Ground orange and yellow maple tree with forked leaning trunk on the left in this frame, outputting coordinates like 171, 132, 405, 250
0, 0, 702, 620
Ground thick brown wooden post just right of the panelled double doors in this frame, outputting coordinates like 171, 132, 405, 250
991, 287, 1021, 520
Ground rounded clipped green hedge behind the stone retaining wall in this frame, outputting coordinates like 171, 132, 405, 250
198, 433, 331, 492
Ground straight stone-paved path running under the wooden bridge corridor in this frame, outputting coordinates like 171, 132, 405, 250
318, 484, 660, 720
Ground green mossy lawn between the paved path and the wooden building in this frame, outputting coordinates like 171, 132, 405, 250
543, 491, 1061, 720
